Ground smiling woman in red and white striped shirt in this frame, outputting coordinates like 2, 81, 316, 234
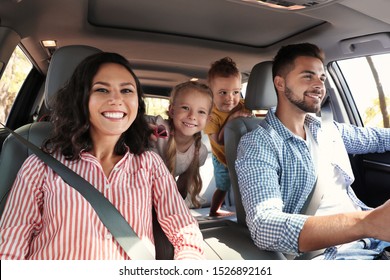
0, 53, 203, 260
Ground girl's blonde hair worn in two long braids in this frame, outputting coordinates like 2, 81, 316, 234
166, 81, 213, 208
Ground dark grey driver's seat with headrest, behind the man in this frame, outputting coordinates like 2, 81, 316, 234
224, 61, 277, 226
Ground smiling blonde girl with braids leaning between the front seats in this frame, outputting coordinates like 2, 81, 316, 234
147, 82, 213, 207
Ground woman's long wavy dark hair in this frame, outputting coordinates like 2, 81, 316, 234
43, 52, 151, 160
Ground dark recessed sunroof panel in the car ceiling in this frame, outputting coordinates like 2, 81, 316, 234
88, 0, 325, 48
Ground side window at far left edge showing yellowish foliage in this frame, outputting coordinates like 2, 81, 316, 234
0, 47, 32, 123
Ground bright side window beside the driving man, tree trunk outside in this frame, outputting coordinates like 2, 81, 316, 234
337, 54, 390, 127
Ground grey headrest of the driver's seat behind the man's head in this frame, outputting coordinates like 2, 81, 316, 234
245, 61, 277, 110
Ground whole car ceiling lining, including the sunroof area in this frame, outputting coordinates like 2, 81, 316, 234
0, 0, 390, 88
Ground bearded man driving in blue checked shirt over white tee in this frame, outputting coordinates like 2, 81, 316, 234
236, 43, 390, 259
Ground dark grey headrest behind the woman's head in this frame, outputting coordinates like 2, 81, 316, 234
45, 45, 101, 109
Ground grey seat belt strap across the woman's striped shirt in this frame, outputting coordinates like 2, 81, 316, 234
0, 123, 154, 260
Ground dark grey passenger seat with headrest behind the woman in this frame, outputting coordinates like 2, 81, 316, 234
0, 45, 101, 217
